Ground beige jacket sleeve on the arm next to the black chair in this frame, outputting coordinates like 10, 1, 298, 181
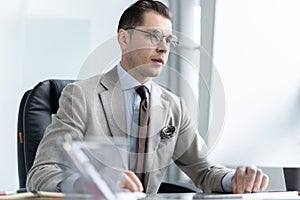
26, 84, 87, 191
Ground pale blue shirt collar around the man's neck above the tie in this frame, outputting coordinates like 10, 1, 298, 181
117, 63, 152, 93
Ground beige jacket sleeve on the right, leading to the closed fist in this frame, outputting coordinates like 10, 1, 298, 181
173, 99, 232, 192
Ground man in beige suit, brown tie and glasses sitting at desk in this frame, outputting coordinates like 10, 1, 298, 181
27, 0, 268, 193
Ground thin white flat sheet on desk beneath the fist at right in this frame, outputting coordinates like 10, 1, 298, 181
193, 191, 299, 199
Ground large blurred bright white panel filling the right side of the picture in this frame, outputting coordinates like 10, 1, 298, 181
211, 0, 300, 189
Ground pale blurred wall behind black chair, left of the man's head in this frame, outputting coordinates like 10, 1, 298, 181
0, 0, 134, 191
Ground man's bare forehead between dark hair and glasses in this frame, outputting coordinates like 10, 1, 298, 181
143, 11, 172, 31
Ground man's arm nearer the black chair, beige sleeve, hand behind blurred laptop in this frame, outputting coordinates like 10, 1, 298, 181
27, 84, 143, 192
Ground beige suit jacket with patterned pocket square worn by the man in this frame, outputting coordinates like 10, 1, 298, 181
27, 67, 229, 193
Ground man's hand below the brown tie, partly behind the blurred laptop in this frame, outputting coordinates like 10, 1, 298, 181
122, 170, 144, 192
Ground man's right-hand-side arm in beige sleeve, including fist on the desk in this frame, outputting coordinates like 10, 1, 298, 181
175, 101, 268, 193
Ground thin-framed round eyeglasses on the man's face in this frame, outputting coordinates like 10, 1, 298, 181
131, 28, 179, 49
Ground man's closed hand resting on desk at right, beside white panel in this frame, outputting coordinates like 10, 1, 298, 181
231, 166, 269, 194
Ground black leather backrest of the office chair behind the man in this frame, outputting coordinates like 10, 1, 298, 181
17, 79, 74, 188
